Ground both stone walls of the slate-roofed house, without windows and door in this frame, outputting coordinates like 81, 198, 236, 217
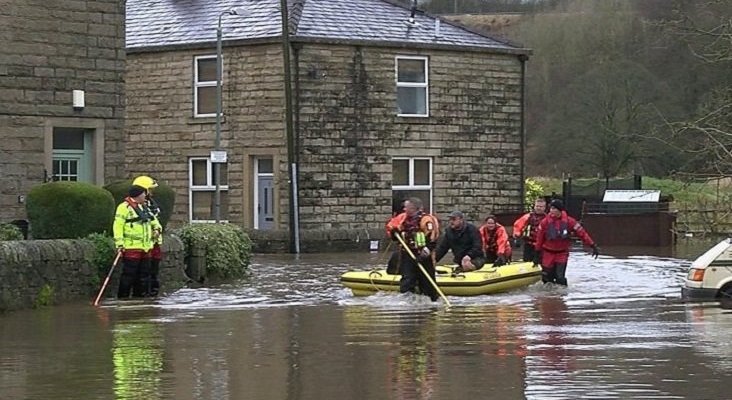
126, 43, 523, 231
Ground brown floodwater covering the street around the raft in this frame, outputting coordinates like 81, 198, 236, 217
0, 241, 732, 400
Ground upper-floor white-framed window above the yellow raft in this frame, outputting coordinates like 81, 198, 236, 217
396, 56, 429, 117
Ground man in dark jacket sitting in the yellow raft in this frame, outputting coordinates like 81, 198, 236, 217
435, 211, 485, 272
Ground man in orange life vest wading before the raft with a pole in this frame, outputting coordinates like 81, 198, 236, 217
386, 197, 440, 301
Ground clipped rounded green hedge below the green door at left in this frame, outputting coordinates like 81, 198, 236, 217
26, 182, 114, 239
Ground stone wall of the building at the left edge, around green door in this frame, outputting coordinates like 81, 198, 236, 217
0, 0, 125, 222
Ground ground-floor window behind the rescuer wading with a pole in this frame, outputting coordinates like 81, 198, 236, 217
391, 158, 432, 213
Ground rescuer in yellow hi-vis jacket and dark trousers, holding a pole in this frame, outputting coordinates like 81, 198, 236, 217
112, 185, 162, 299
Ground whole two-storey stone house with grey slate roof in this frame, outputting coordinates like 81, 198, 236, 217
125, 0, 529, 245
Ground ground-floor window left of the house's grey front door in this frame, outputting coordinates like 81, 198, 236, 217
188, 157, 229, 222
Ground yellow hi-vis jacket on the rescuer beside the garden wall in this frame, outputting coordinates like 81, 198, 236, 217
112, 198, 163, 252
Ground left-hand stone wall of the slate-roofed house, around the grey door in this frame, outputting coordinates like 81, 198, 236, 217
126, 43, 287, 228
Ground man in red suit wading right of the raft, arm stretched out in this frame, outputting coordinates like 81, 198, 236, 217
534, 199, 600, 286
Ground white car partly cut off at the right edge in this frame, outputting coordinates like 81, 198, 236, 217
681, 238, 732, 299
